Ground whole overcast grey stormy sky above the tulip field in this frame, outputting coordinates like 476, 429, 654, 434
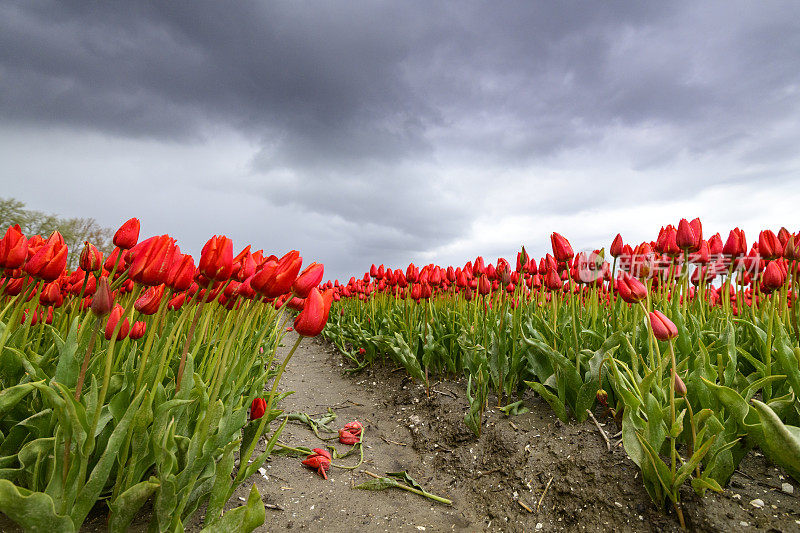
0, 0, 800, 279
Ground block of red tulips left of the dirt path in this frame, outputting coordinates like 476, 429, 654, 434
0, 218, 333, 531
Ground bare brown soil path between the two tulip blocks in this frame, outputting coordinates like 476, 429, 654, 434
0, 333, 800, 532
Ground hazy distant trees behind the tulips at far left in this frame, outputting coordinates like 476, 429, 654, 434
0, 198, 114, 269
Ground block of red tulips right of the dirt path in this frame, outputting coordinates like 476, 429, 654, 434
325, 219, 800, 520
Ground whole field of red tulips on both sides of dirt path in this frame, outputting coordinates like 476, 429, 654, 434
0, 218, 800, 531
